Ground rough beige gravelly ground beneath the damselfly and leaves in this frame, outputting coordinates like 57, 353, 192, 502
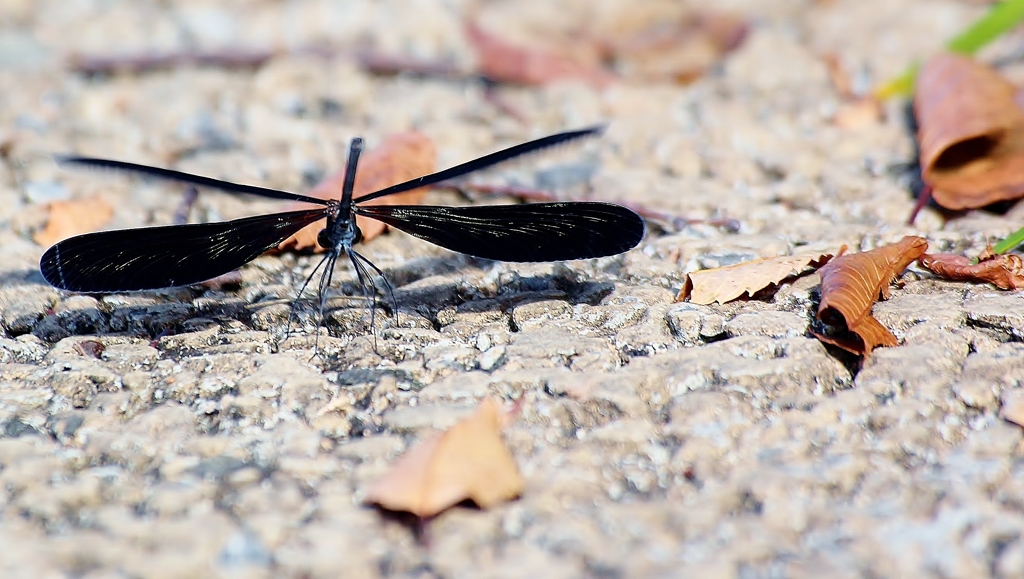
0, 0, 1024, 578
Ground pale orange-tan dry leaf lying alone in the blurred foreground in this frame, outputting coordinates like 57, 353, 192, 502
364, 399, 523, 519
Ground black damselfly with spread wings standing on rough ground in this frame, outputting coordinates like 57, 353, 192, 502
39, 127, 644, 329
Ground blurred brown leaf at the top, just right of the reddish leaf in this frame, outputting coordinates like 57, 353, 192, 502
602, 10, 749, 83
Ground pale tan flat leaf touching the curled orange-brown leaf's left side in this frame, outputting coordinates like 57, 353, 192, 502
676, 249, 833, 304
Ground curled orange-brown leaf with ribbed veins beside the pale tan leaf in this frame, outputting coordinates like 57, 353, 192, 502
812, 236, 928, 356
